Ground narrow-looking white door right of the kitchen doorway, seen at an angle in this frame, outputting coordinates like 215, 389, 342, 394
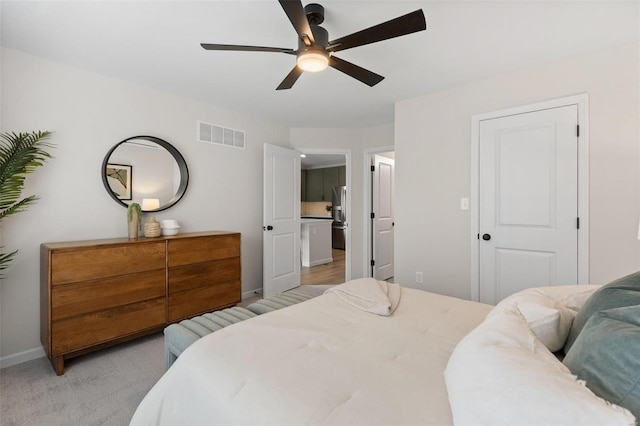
372, 155, 394, 280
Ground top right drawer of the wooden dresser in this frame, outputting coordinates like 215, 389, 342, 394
167, 234, 240, 267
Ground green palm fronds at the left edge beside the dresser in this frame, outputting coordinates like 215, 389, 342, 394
0, 131, 53, 270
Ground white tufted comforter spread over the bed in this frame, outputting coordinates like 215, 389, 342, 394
131, 288, 491, 425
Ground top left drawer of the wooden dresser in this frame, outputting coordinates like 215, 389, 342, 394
51, 241, 166, 286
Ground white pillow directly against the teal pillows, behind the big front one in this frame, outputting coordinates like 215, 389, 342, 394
490, 286, 575, 352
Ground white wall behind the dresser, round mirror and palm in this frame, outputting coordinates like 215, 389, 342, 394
0, 49, 289, 365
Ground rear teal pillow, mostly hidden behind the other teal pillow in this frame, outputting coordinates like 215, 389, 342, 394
564, 272, 640, 353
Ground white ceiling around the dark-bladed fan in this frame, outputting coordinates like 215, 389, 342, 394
0, 0, 640, 128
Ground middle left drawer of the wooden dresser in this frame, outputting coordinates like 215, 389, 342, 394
51, 269, 166, 321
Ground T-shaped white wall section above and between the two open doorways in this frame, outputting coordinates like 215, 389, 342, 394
291, 124, 393, 279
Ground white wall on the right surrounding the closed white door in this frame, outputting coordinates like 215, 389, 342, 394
395, 43, 640, 298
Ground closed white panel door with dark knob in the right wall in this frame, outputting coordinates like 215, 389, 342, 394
478, 105, 578, 304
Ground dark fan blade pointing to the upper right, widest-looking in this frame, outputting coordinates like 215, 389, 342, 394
327, 9, 427, 52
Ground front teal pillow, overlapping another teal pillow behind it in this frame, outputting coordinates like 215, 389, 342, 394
563, 305, 640, 419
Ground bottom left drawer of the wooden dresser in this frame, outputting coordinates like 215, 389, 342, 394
51, 297, 166, 356
